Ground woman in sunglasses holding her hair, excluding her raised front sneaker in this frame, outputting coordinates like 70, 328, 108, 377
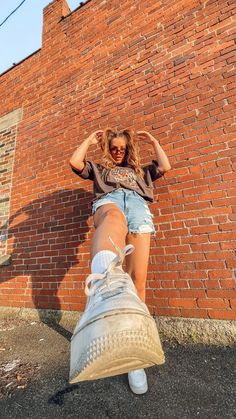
70, 128, 171, 394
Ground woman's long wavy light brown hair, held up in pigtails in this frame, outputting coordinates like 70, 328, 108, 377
101, 128, 144, 178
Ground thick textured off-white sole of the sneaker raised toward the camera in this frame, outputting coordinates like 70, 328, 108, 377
69, 310, 165, 384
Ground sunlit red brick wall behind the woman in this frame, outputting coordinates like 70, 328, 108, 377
0, 0, 236, 319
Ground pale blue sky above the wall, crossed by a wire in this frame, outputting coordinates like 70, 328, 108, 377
0, 0, 82, 74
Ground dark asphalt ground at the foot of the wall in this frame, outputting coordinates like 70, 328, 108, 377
0, 319, 236, 419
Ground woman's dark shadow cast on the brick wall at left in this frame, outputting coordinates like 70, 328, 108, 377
0, 189, 93, 340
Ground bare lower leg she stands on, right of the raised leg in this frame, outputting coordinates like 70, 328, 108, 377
126, 233, 151, 302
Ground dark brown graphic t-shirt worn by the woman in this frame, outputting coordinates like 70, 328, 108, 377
71, 160, 163, 202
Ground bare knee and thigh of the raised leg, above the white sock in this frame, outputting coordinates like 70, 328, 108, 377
91, 204, 128, 259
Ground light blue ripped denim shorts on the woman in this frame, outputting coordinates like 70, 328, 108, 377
92, 188, 155, 234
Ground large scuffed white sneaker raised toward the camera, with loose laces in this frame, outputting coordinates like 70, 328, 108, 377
70, 236, 165, 384
